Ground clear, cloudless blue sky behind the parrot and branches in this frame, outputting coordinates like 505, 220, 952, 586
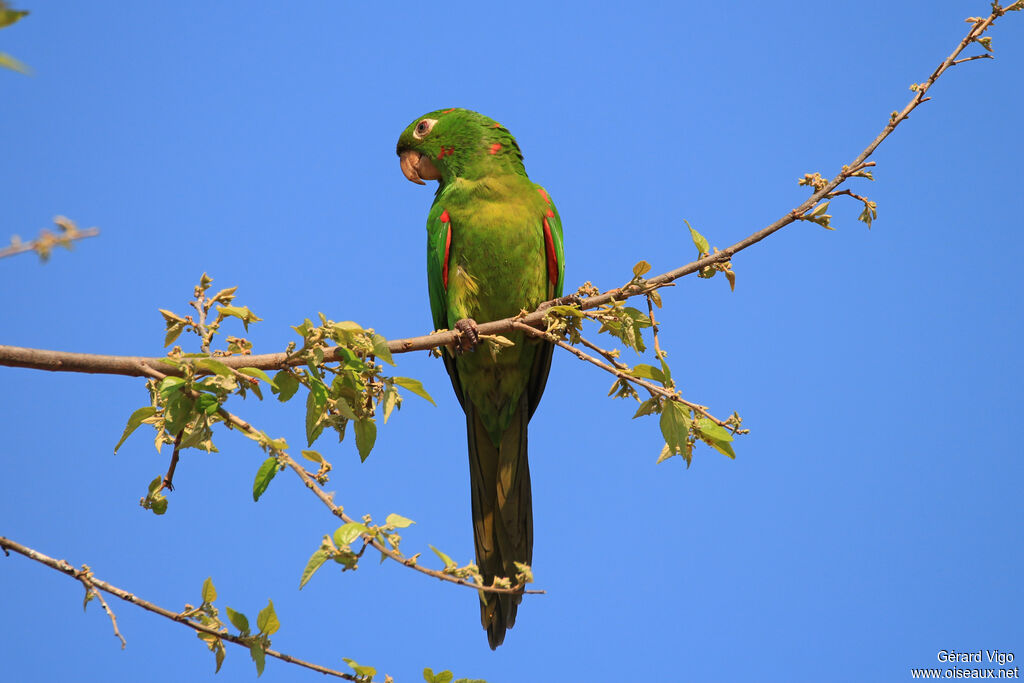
0, 0, 1024, 683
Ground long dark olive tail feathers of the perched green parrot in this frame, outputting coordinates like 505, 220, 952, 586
466, 393, 534, 649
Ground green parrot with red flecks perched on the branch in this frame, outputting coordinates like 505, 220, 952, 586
397, 109, 564, 649
